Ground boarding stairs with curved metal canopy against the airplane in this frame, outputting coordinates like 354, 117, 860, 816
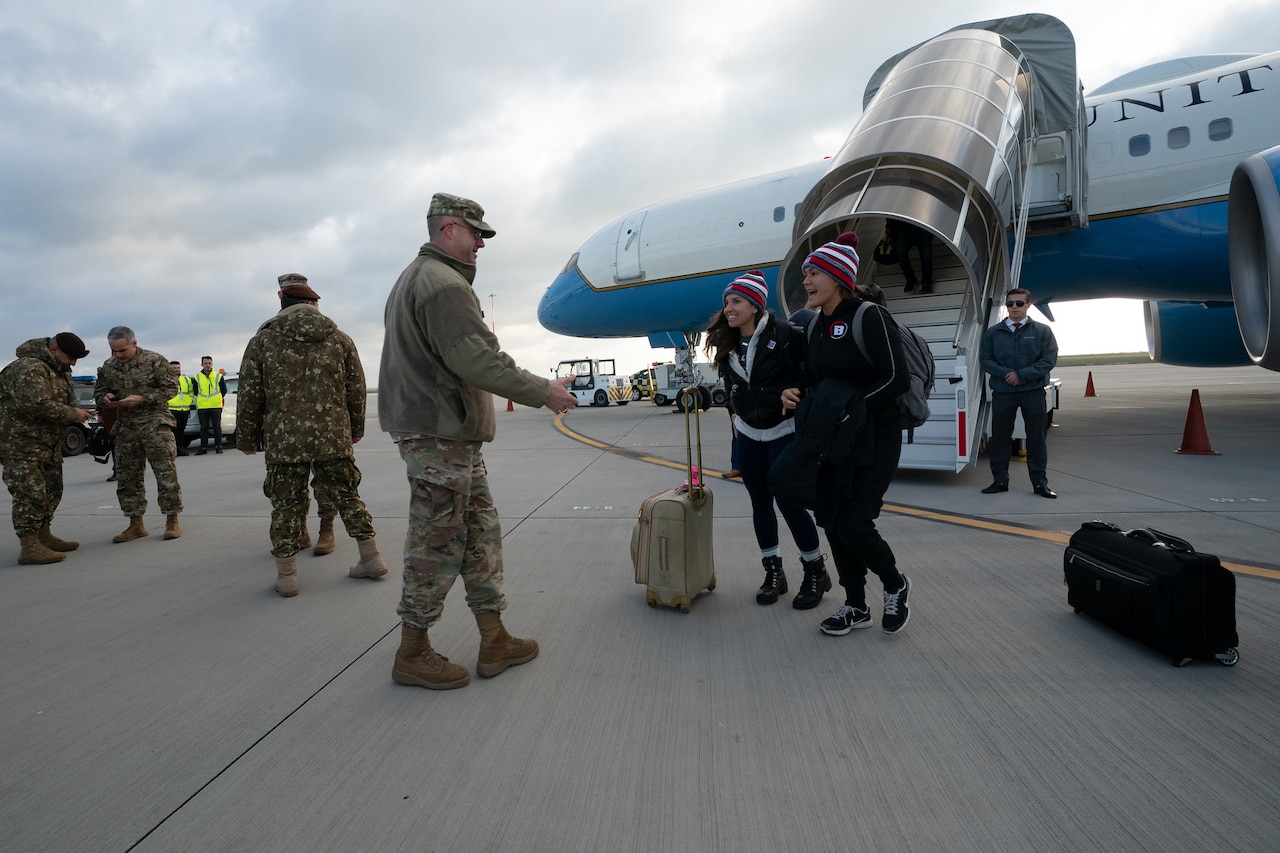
778, 15, 1083, 471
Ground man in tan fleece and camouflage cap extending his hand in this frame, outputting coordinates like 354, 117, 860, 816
378, 192, 577, 690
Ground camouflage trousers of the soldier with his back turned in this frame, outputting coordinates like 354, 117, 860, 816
262, 459, 374, 557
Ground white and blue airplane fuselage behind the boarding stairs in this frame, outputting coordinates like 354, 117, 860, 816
539, 53, 1280, 364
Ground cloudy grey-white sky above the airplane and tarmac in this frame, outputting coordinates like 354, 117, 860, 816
0, 0, 1280, 383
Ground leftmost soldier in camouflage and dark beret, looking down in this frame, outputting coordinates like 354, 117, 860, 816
0, 332, 90, 565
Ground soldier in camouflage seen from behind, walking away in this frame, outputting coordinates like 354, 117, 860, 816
236, 273, 387, 597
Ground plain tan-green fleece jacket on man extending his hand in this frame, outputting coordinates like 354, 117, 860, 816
378, 243, 550, 442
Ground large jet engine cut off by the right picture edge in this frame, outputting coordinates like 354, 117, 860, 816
1223, 146, 1280, 370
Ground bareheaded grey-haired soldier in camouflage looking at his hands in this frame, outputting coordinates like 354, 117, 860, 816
93, 325, 182, 542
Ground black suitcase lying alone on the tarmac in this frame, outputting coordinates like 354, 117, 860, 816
1062, 521, 1240, 666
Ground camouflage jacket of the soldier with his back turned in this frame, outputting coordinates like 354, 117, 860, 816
236, 298, 367, 464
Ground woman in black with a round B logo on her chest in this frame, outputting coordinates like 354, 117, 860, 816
782, 232, 911, 637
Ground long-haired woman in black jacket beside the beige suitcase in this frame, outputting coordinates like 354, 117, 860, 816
704, 270, 831, 610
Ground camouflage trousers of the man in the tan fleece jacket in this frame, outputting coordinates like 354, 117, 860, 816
396, 438, 507, 628
